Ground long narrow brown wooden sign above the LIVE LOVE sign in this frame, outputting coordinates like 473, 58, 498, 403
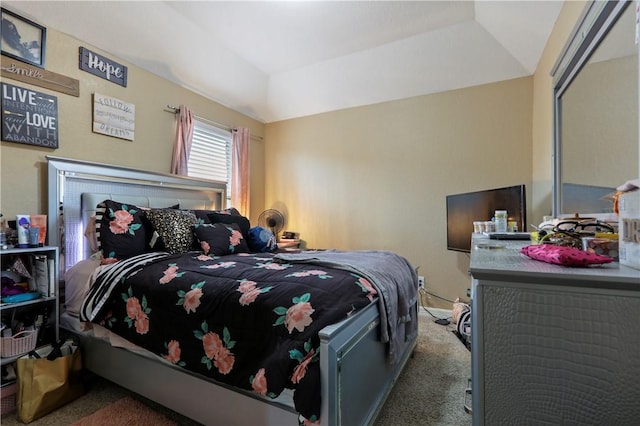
2, 55, 80, 96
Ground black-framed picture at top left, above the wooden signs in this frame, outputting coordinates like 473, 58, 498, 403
0, 8, 47, 68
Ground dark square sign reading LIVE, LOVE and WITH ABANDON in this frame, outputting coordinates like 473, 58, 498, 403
2, 83, 58, 149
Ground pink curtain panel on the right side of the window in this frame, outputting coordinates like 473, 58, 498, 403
231, 127, 251, 217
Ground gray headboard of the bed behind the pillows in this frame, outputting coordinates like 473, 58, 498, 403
47, 156, 226, 276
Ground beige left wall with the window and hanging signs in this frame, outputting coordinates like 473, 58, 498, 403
0, 22, 264, 223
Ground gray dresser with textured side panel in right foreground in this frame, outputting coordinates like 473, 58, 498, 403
471, 238, 640, 426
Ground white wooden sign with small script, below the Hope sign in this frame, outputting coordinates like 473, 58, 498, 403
93, 93, 136, 141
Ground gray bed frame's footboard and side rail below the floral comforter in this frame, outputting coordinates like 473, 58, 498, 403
71, 303, 416, 426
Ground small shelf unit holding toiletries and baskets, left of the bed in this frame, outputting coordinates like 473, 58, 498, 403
0, 246, 60, 366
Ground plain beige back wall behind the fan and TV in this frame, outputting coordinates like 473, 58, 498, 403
265, 77, 533, 307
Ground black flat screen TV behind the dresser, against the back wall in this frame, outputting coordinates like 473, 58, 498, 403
447, 185, 527, 252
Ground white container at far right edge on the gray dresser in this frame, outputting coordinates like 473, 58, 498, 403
618, 190, 640, 269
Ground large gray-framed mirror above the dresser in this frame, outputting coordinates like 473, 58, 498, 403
552, 1, 640, 217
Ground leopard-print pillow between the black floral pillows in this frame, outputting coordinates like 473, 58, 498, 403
145, 209, 198, 254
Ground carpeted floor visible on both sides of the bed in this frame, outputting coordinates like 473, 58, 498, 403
1, 309, 471, 426
